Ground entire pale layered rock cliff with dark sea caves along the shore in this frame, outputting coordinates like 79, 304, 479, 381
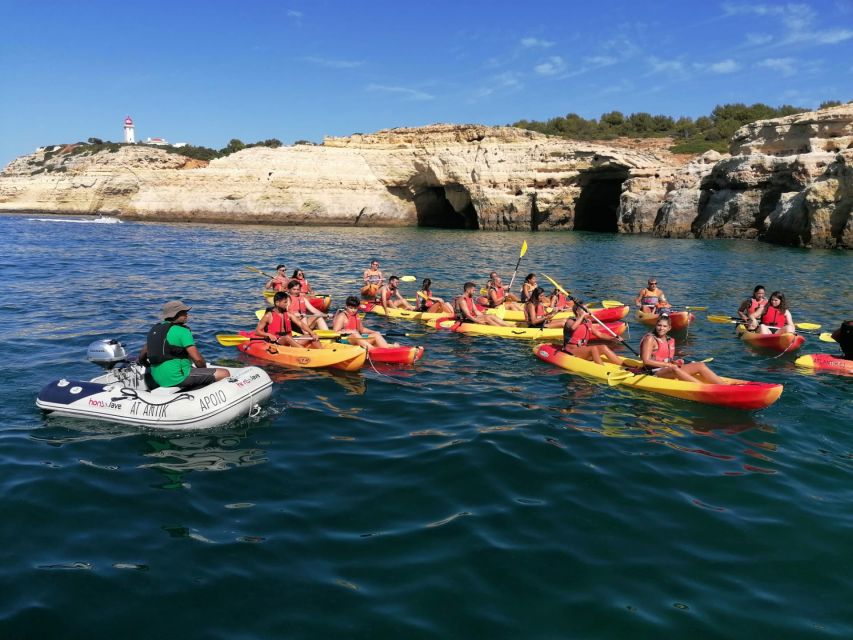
0, 105, 853, 248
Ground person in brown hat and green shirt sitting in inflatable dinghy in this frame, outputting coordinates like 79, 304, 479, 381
139, 300, 231, 389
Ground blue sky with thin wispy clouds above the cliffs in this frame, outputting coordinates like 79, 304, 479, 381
0, 0, 853, 166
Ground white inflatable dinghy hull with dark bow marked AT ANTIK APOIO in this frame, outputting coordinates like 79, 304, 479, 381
36, 365, 272, 431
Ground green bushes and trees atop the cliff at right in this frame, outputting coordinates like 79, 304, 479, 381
512, 100, 841, 153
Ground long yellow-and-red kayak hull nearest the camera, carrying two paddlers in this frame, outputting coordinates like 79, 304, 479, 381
533, 344, 783, 411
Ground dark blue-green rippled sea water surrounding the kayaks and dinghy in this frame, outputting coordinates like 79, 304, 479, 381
0, 215, 853, 638
